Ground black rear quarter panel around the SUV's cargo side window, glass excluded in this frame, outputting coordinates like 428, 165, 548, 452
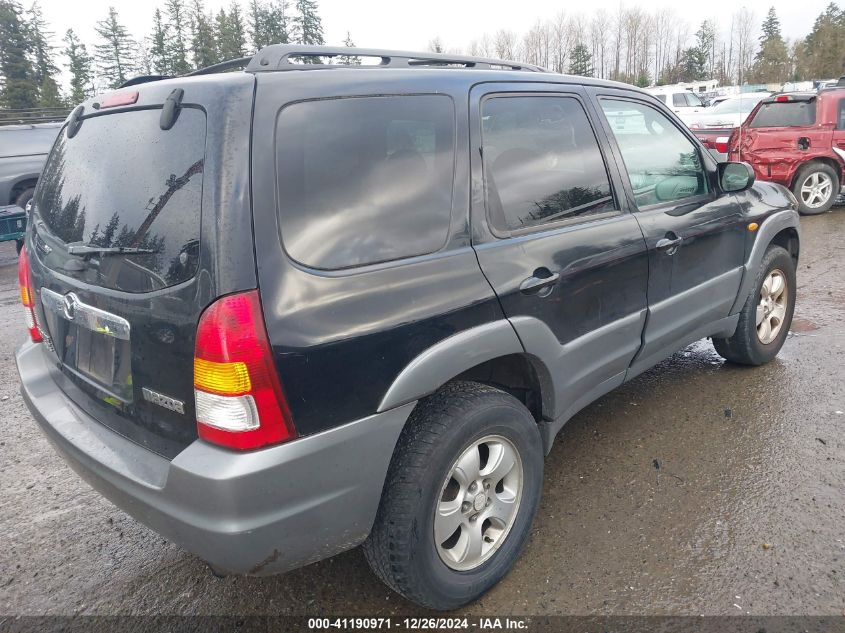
247, 69, 503, 435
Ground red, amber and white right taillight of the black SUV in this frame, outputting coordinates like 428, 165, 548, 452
194, 290, 296, 450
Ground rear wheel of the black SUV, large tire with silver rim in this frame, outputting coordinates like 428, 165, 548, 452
364, 382, 543, 610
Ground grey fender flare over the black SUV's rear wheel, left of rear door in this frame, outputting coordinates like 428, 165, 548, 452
378, 319, 525, 413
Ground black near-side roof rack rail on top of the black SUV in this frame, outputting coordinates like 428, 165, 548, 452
244, 44, 548, 74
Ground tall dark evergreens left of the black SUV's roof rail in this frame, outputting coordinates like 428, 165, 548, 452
0, 0, 336, 109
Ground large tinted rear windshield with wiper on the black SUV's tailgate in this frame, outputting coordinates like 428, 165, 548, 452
34, 108, 205, 292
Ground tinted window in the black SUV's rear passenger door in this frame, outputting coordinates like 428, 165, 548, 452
482, 96, 615, 231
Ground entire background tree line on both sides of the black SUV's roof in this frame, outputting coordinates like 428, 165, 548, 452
0, 0, 845, 109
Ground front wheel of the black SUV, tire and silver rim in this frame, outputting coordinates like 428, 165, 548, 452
713, 246, 795, 366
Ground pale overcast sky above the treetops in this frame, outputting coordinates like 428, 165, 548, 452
38, 0, 830, 61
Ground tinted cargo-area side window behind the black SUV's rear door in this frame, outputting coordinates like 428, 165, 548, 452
276, 95, 455, 269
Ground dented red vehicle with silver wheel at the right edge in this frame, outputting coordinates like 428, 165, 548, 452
728, 87, 845, 215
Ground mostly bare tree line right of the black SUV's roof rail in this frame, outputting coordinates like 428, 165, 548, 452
436, 2, 845, 86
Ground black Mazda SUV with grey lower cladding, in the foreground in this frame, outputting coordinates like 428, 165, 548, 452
17, 46, 799, 609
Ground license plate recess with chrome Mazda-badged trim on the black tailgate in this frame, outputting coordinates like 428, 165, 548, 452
41, 288, 132, 404
